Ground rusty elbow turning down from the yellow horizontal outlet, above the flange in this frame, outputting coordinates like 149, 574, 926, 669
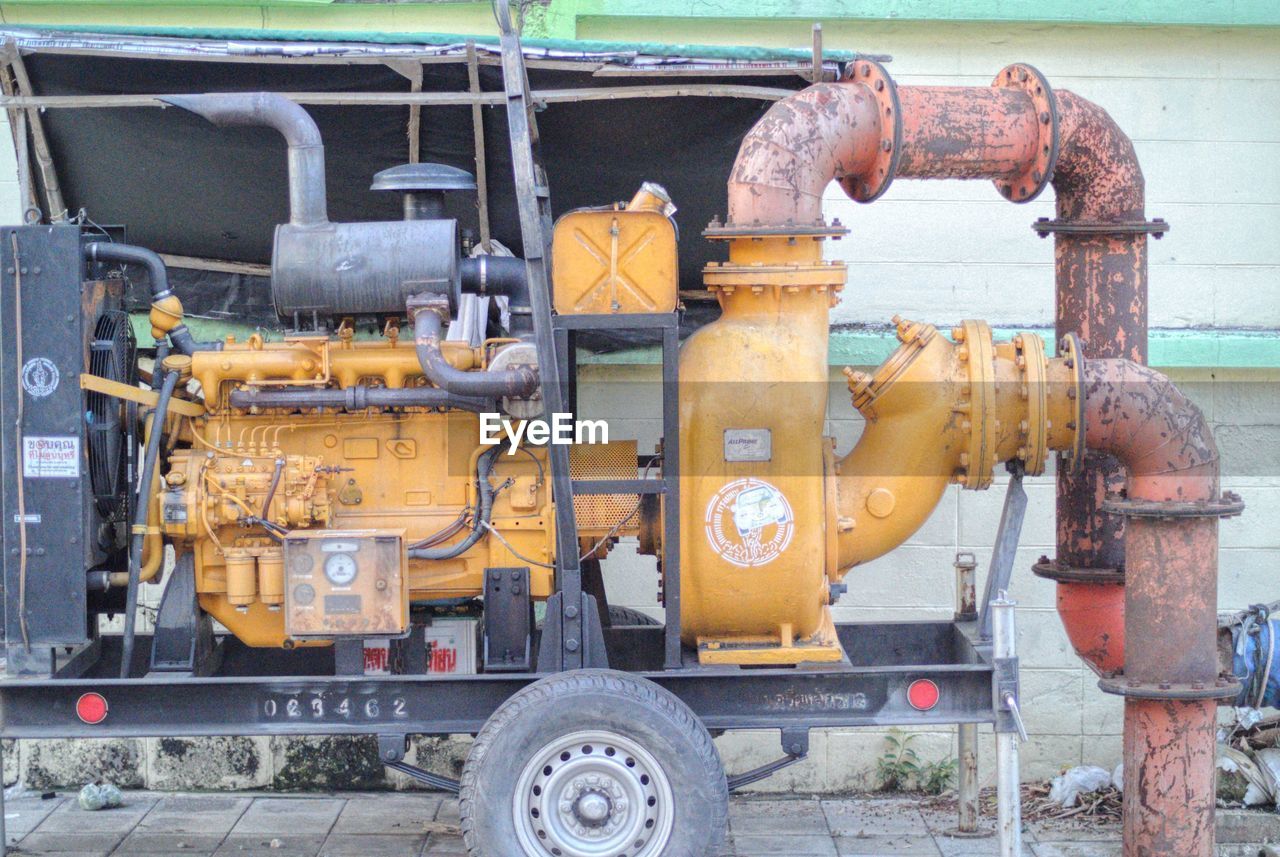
1084, 358, 1219, 503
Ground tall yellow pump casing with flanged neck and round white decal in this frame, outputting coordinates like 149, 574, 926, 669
680, 237, 845, 664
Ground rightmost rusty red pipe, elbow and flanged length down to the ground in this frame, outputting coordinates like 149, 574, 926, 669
1084, 359, 1222, 857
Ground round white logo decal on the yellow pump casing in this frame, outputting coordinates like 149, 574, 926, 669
704, 478, 795, 568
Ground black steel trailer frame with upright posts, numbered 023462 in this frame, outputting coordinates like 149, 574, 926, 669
0, 10, 1027, 842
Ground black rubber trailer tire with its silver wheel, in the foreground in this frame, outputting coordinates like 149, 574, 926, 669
458, 669, 728, 857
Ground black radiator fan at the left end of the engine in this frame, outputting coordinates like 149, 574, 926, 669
84, 310, 137, 522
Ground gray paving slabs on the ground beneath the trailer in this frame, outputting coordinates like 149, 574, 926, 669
5, 792, 1259, 857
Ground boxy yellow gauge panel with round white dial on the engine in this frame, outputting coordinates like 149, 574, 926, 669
283, 530, 408, 640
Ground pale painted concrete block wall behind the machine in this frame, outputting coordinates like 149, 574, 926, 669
0, 19, 1280, 792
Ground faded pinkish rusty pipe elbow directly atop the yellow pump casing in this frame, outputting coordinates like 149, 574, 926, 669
728, 82, 882, 226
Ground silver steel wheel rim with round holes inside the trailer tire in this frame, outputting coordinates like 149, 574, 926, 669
512, 730, 675, 857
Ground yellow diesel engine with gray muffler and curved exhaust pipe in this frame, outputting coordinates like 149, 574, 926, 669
113, 95, 645, 649
